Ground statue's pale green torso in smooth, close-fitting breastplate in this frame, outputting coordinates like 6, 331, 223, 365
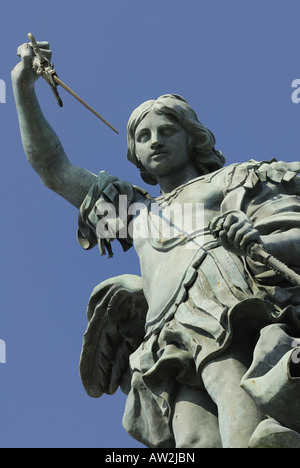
133, 170, 224, 330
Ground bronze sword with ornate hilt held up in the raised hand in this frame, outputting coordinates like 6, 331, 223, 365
28, 33, 119, 133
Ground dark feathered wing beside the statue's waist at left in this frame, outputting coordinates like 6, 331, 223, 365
79, 275, 148, 398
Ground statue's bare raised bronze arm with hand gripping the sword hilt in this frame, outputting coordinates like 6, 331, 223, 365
11, 42, 96, 208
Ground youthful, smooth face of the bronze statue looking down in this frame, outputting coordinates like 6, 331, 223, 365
135, 111, 190, 177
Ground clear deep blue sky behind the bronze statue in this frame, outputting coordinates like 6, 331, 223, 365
0, 0, 300, 448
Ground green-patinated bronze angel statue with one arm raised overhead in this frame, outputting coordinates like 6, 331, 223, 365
12, 38, 300, 448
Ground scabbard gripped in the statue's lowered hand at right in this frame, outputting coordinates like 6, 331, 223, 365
209, 217, 300, 286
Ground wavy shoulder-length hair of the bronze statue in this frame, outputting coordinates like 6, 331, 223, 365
127, 94, 226, 185
